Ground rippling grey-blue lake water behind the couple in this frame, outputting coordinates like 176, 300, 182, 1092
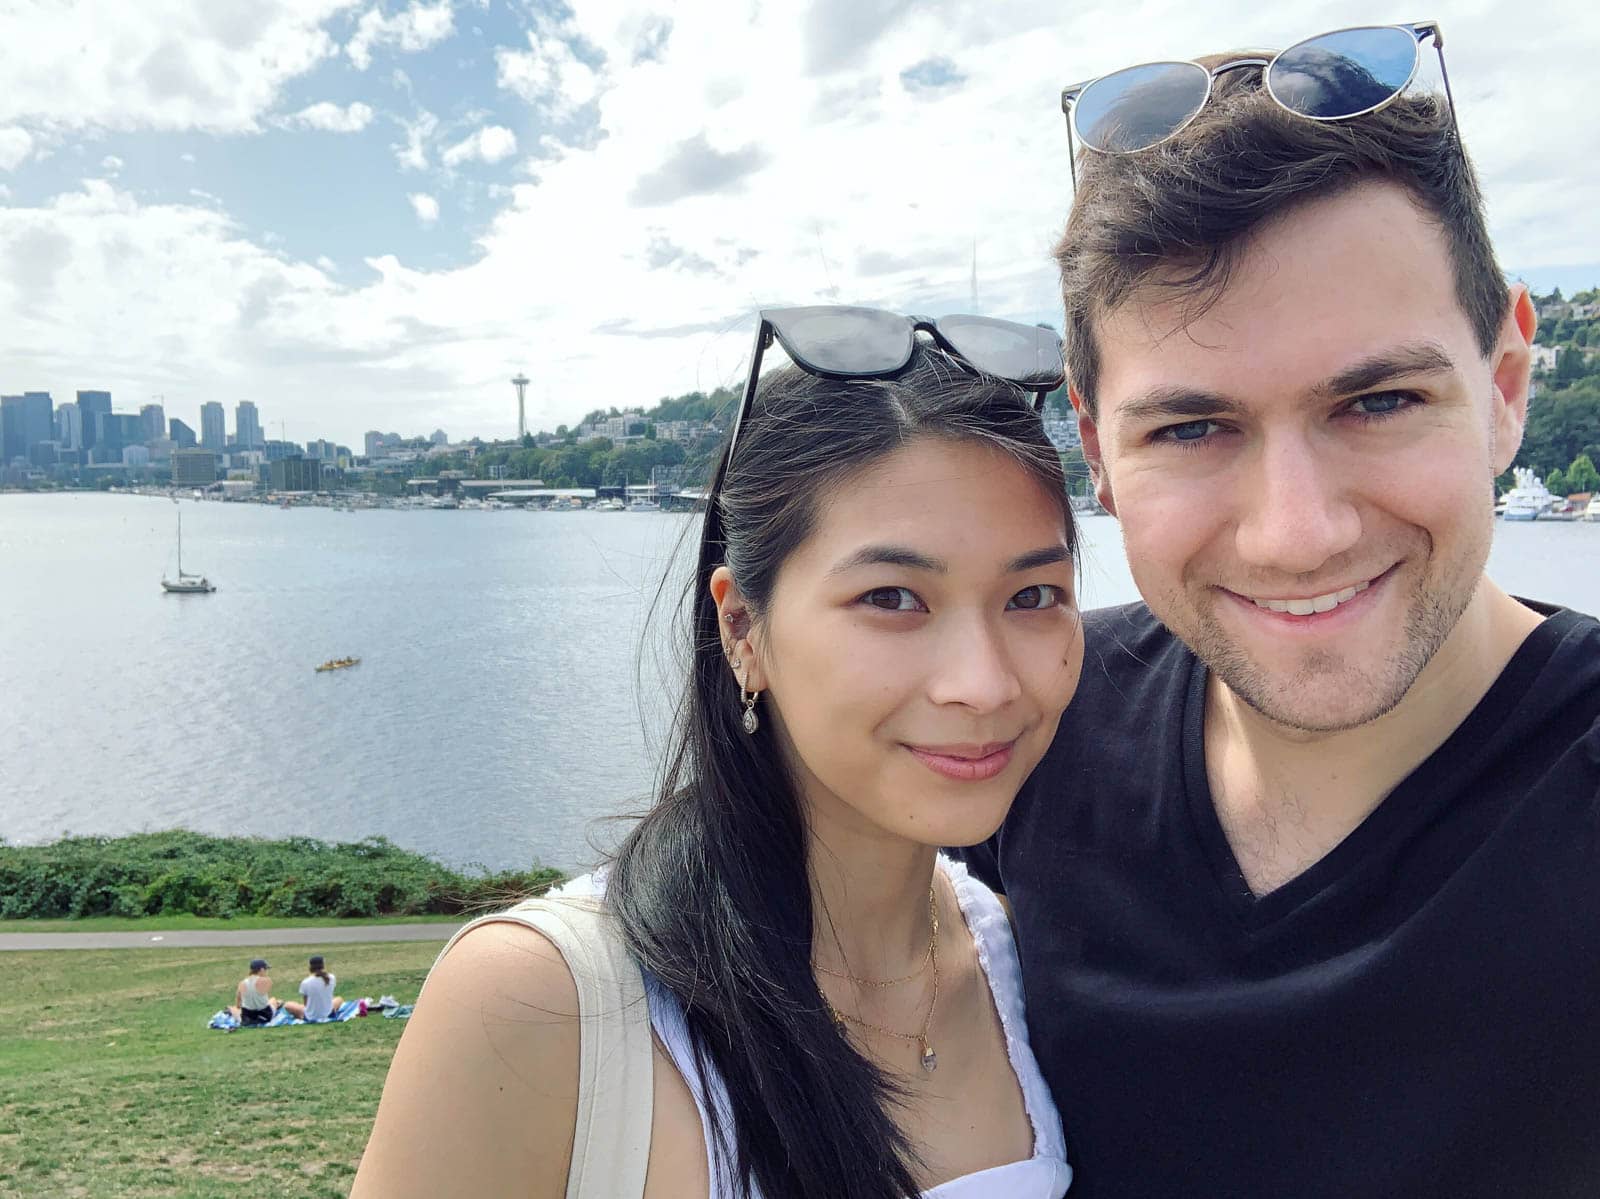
0, 495, 1600, 868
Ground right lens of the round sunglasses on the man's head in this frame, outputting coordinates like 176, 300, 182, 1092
1267, 26, 1416, 120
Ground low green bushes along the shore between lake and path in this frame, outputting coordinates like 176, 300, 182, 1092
0, 829, 565, 919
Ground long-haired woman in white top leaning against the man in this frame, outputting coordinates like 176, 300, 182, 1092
354, 309, 1082, 1199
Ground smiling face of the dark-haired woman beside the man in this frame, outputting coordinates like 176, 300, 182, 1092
726, 437, 1083, 845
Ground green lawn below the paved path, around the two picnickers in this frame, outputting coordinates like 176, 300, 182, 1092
0, 941, 440, 1199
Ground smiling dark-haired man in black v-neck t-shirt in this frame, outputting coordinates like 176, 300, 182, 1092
968, 32, 1600, 1199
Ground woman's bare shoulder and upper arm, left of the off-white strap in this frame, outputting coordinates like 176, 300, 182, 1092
352, 920, 578, 1199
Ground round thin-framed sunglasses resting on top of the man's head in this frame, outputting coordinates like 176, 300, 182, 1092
1061, 21, 1461, 187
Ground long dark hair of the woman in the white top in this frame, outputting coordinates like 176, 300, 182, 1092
606, 344, 1074, 1199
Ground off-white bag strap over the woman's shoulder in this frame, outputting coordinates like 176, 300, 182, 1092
446, 896, 654, 1199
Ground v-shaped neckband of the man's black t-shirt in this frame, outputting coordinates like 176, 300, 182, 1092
1182, 600, 1581, 933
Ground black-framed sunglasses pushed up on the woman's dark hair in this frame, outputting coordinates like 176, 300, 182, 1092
718, 304, 1067, 479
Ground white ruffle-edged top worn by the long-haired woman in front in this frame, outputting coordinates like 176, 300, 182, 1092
630, 856, 1072, 1199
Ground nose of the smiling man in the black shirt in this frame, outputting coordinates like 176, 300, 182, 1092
1235, 431, 1362, 575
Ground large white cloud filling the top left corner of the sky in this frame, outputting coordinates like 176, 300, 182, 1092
0, 0, 350, 133
